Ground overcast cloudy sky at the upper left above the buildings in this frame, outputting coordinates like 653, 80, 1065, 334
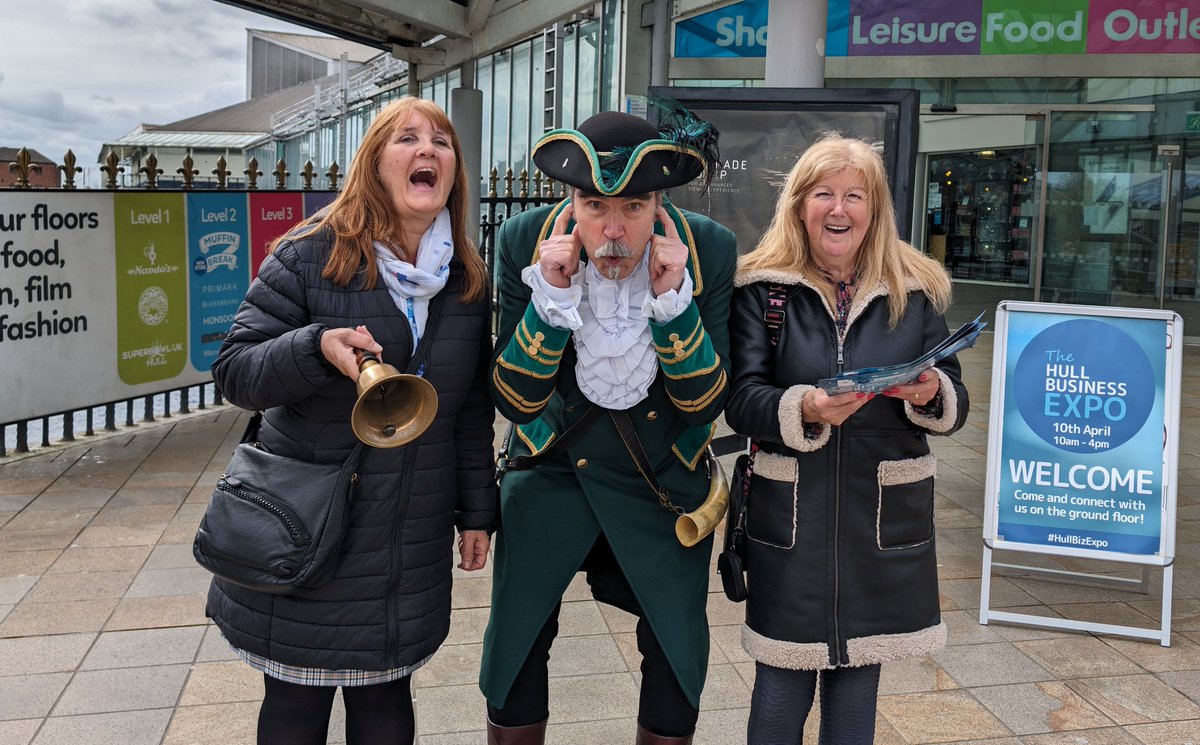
0, 0, 316, 182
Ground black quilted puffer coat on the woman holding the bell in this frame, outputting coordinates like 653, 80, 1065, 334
206, 226, 496, 671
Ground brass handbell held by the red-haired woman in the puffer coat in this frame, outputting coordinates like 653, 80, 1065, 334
350, 349, 438, 447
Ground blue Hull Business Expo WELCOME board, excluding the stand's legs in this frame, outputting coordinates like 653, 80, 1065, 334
985, 298, 1182, 558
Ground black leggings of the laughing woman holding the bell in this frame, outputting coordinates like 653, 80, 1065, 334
258, 675, 415, 745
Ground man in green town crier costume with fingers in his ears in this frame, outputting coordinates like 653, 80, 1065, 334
480, 106, 737, 745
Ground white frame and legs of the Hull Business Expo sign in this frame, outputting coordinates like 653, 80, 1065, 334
979, 301, 1183, 647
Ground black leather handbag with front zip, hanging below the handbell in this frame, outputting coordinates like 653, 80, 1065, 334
192, 413, 366, 595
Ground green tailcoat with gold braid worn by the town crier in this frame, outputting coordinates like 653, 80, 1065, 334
480, 202, 737, 708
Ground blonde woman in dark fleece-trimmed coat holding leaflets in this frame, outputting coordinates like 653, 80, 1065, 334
726, 134, 967, 745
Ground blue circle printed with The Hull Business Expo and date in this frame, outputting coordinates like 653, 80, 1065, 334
1013, 319, 1156, 452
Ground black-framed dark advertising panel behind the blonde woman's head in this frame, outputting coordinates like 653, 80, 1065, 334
649, 88, 920, 253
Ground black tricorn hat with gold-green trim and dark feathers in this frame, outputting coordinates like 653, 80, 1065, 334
533, 104, 718, 197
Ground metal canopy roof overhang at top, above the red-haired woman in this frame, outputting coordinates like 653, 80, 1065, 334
217, 0, 595, 80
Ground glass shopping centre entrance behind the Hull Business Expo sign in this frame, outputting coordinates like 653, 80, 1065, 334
913, 101, 1200, 342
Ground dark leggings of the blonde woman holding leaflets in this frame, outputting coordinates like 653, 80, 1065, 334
746, 662, 880, 745
